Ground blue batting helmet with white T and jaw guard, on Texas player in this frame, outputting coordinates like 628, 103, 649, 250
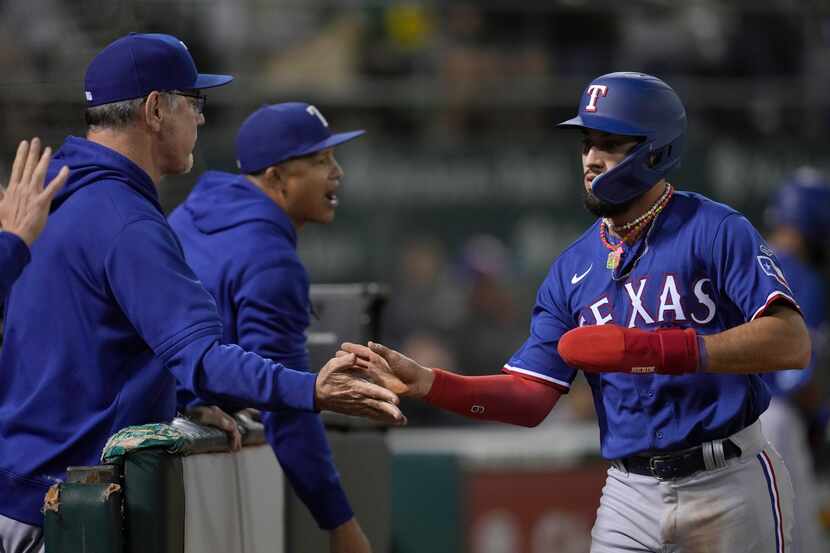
557, 73, 686, 204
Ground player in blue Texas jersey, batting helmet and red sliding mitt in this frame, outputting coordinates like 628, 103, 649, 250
343, 73, 810, 553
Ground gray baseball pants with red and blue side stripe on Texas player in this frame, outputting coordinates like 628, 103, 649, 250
591, 422, 793, 553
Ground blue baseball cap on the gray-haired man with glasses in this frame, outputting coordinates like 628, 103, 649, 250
84, 33, 233, 107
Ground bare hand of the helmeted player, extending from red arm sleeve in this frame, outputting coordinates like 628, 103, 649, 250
340, 342, 434, 398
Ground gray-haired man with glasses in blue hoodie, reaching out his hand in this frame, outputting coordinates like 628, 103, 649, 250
0, 34, 404, 553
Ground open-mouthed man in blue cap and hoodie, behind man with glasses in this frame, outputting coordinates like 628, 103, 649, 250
169, 102, 371, 553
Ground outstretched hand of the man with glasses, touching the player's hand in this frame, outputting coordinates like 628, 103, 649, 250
315, 354, 406, 425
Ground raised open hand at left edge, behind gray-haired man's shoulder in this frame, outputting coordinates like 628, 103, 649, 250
0, 138, 69, 246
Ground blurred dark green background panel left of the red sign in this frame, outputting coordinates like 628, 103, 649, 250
392, 453, 465, 553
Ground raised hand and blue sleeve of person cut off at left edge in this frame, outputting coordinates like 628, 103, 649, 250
0, 138, 69, 304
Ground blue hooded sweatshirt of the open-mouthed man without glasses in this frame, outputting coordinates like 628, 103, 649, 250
169, 171, 353, 530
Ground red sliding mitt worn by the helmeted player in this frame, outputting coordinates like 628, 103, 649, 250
557, 324, 700, 374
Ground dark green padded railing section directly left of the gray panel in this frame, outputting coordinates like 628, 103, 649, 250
123, 449, 185, 553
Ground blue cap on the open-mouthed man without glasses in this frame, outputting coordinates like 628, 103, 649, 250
236, 102, 366, 174
